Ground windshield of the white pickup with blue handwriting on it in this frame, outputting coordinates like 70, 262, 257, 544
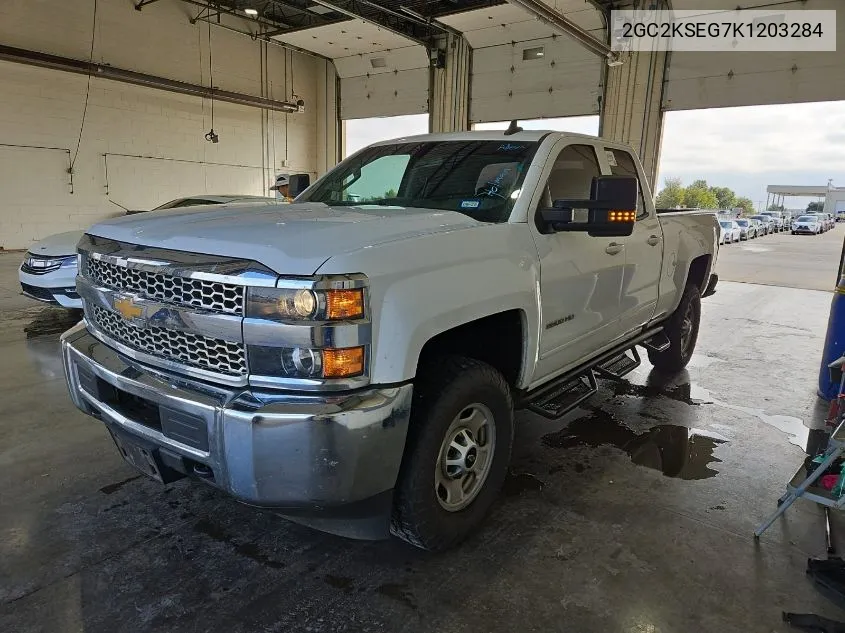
296, 141, 537, 222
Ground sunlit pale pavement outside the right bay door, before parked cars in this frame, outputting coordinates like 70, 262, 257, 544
717, 223, 845, 290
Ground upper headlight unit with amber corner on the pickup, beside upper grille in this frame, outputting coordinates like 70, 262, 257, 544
246, 288, 365, 321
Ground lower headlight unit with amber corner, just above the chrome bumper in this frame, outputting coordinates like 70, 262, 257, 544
248, 345, 366, 379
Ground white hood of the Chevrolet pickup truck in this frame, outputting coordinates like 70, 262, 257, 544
88, 203, 484, 275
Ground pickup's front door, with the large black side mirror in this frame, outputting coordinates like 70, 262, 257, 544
529, 139, 625, 380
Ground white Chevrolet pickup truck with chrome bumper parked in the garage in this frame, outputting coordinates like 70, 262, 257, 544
62, 130, 718, 550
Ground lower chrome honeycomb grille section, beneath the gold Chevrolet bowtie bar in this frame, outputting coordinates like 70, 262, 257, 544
87, 306, 247, 376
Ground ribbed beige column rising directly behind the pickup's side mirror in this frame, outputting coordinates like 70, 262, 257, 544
599, 52, 667, 193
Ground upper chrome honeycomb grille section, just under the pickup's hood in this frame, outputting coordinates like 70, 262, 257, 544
85, 256, 245, 316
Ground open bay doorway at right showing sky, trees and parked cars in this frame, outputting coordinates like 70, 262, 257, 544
655, 101, 845, 290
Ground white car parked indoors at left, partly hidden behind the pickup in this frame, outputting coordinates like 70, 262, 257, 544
18, 196, 277, 309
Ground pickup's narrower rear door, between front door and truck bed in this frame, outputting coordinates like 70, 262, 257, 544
605, 148, 663, 332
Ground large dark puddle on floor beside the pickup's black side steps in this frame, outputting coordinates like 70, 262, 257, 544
542, 409, 727, 480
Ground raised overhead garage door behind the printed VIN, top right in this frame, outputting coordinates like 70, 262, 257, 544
664, 0, 845, 110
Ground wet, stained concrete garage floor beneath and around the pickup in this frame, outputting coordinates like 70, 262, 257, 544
0, 236, 845, 633
